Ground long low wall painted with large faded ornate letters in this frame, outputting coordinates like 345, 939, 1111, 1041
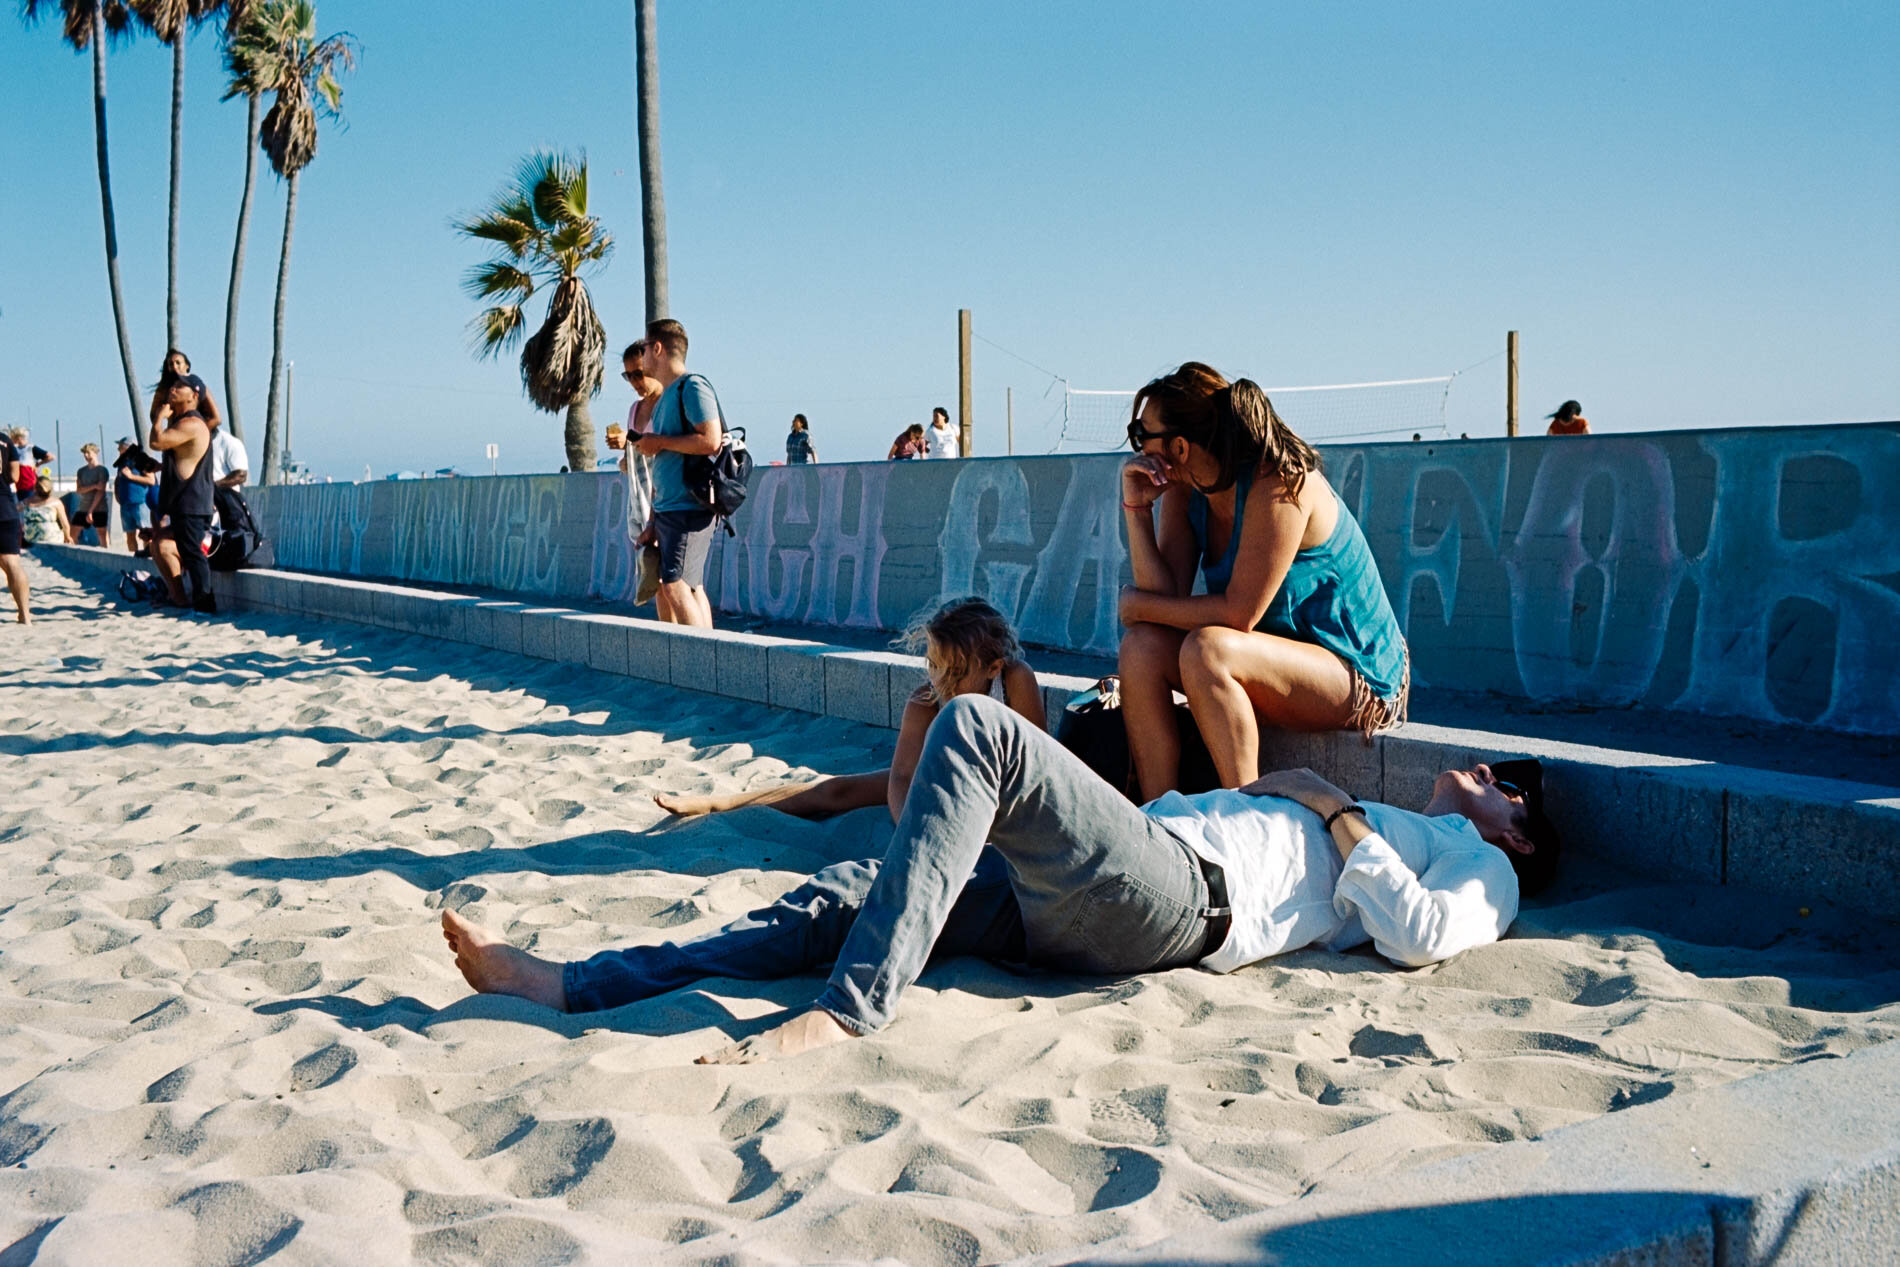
255, 424, 1900, 733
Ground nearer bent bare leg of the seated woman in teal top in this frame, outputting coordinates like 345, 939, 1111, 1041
1178, 625, 1353, 788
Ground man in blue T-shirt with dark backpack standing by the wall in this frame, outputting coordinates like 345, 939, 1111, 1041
627, 317, 726, 629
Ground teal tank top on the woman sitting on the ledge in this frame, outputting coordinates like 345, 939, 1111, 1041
1188, 471, 1406, 699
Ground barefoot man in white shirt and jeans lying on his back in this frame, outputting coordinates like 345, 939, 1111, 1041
443, 695, 1558, 1064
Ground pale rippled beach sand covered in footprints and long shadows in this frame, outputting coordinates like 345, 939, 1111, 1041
0, 566, 1900, 1267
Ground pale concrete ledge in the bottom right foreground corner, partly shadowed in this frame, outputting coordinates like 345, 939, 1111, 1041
1064, 1043, 1900, 1267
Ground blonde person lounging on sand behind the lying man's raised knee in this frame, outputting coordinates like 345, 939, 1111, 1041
654, 598, 1045, 821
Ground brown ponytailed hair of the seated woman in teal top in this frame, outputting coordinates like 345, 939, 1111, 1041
1129, 361, 1322, 498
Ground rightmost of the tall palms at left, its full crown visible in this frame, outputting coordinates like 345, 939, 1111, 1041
232, 0, 357, 484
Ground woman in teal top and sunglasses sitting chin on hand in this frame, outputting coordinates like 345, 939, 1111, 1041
1121, 361, 1410, 800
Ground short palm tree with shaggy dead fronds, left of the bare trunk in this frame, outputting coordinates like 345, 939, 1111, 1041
454, 150, 614, 471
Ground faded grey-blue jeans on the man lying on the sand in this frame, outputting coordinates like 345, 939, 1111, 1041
562, 695, 1207, 1033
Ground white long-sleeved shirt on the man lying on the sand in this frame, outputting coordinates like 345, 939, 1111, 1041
1144, 790, 1518, 973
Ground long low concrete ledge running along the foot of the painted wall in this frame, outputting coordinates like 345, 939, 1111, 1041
34, 545, 1900, 919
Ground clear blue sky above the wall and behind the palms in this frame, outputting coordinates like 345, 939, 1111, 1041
0, 0, 1900, 479
